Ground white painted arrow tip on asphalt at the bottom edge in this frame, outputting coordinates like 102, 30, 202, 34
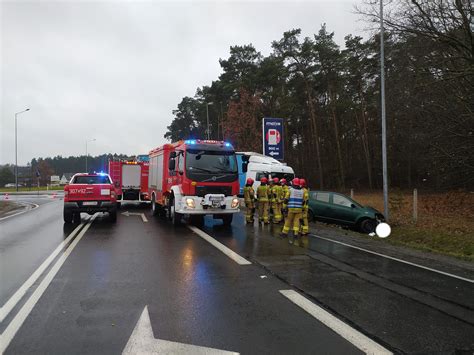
122, 306, 239, 355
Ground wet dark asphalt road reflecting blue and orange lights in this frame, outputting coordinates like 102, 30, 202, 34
0, 202, 474, 354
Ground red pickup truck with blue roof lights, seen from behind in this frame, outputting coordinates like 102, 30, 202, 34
63, 173, 117, 223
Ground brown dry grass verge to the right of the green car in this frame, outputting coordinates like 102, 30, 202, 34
354, 191, 474, 261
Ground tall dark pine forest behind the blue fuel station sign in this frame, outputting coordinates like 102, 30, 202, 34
165, 0, 474, 190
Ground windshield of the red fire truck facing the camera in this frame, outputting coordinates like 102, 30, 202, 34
186, 150, 237, 181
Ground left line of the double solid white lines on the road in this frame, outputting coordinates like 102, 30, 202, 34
0, 223, 88, 323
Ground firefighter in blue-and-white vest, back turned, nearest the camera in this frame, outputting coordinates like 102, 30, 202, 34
281, 178, 304, 244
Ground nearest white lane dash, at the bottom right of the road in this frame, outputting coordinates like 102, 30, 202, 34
280, 290, 392, 355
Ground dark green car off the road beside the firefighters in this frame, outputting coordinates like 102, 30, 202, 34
308, 191, 384, 233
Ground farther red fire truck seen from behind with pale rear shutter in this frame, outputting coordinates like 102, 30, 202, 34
109, 160, 150, 208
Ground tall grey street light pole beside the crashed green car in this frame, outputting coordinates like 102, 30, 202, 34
380, 0, 389, 221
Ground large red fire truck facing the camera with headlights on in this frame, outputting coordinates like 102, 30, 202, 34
148, 140, 240, 225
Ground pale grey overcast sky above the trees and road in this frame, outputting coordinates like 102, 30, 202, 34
0, 0, 364, 164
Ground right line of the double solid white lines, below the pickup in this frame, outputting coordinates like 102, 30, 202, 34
0, 213, 97, 354
